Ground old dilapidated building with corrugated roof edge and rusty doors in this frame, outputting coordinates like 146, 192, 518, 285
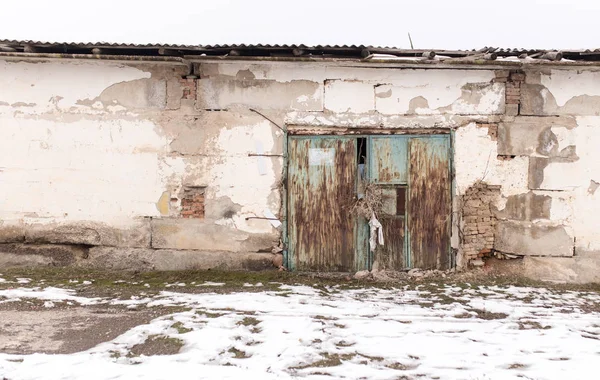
0, 41, 600, 282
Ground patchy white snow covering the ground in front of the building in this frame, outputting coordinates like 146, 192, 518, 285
0, 283, 600, 380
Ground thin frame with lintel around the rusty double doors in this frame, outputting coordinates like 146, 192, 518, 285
281, 129, 456, 271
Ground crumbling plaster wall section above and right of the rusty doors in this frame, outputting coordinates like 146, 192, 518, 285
198, 62, 600, 280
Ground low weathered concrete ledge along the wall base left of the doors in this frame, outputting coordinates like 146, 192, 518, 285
0, 244, 273, 271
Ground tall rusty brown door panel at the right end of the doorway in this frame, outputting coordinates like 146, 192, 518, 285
408, 136, 451, 269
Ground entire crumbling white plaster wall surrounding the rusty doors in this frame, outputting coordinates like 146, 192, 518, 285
0, 56, 600, 280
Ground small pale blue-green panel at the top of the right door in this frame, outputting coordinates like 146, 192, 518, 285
369, 136, 408, 184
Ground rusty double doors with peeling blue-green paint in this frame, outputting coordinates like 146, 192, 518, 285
286, 135, 452, 272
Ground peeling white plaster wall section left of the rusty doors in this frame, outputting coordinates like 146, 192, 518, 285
0, 60, 283, 269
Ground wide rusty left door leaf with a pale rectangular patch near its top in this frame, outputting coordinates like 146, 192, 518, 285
288, 137, 357, 271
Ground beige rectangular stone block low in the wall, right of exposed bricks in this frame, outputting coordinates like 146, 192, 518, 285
494, 221, 575, 257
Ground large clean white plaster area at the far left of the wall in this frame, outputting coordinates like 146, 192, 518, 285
0, 61, 167, 225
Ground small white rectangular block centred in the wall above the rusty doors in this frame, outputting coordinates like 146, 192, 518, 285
325, 80, 375, 113
